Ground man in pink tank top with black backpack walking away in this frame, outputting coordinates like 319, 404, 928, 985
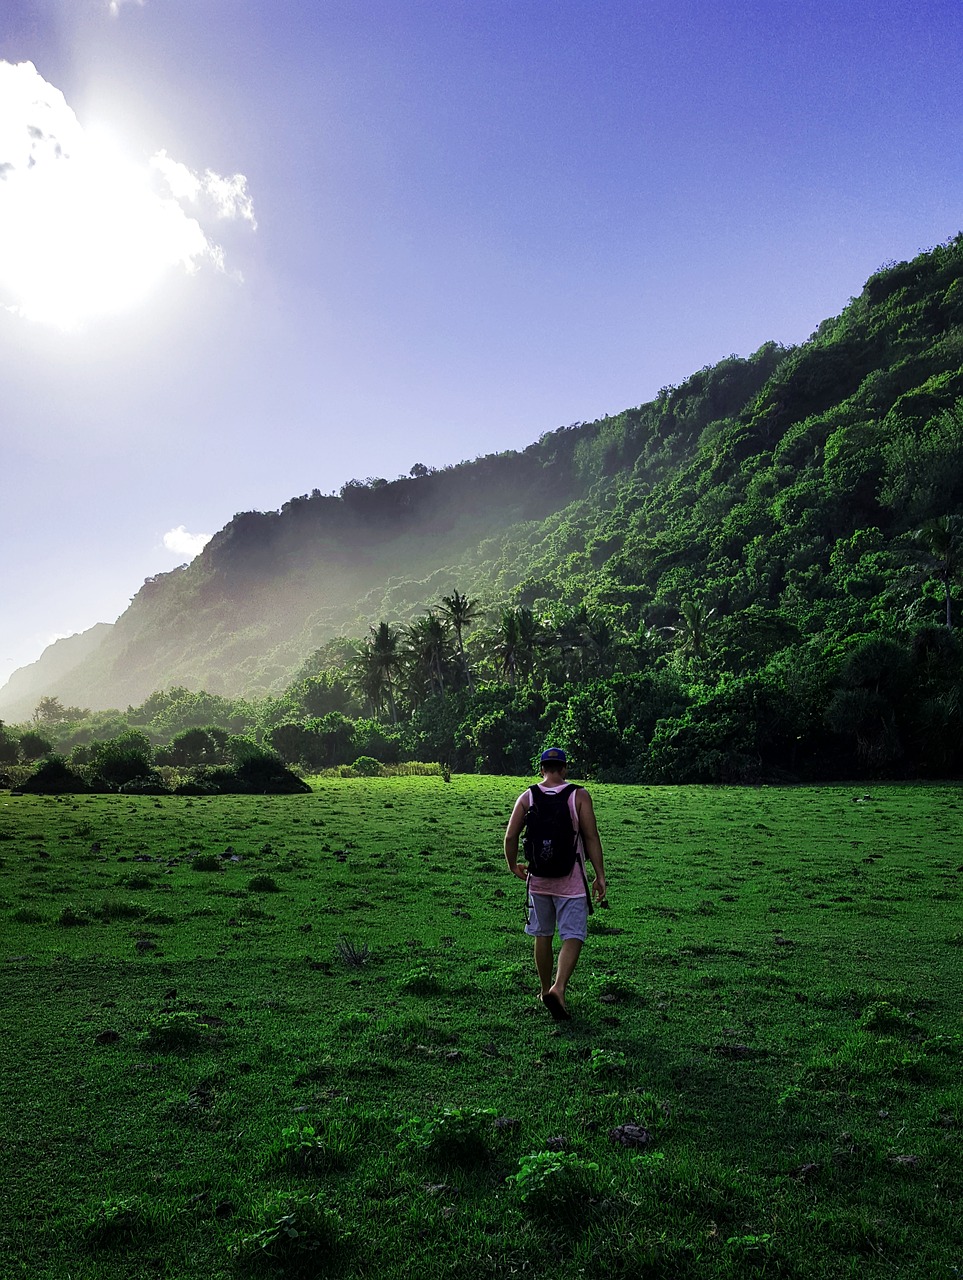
505, 746, 606, 1021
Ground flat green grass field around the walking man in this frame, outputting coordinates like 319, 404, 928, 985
0, 777, 963, 1280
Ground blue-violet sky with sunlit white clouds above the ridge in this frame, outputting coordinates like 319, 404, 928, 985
0, 0, 963, 696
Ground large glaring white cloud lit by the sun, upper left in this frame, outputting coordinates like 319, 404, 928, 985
0, 61, 256, 329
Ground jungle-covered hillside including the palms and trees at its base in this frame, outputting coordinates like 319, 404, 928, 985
0, 237, 963, 782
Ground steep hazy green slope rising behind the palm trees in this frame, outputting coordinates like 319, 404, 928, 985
0, 237, 963, 719
